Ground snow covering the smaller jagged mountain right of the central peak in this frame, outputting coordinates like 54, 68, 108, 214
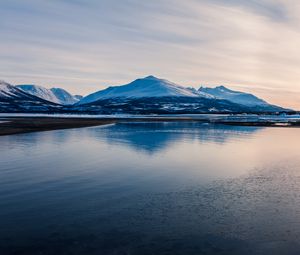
198, 86, 268, 106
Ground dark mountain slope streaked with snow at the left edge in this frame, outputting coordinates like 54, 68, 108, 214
0, 81, 59, 112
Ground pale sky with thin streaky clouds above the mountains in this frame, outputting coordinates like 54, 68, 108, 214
0, 0, 300, 109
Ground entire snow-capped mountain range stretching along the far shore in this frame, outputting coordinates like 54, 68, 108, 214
0, 76, 287, 114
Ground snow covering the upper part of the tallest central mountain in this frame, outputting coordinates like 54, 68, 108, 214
79, 76, 213, 104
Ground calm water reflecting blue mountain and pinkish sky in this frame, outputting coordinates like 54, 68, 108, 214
0, 123, 300, 255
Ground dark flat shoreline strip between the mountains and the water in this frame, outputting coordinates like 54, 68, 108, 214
0, 116, 300, 136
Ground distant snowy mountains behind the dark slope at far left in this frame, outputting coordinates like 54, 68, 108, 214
16, 84, 79, 105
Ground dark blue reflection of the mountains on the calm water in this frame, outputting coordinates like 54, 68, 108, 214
91, 122, 263, 153
